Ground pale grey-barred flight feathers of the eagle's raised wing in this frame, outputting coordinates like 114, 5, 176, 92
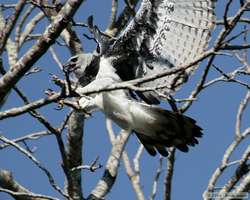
149, 0, 215, 66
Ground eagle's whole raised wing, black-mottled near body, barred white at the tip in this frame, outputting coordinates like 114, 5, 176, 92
108, 0, 215, 103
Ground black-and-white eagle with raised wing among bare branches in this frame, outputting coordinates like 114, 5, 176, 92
64, 0, 216, 156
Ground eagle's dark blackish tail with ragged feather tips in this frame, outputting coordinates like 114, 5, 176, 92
134, 104, 202, 156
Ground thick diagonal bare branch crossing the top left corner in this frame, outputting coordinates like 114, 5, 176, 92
0, 0, 83, 105
